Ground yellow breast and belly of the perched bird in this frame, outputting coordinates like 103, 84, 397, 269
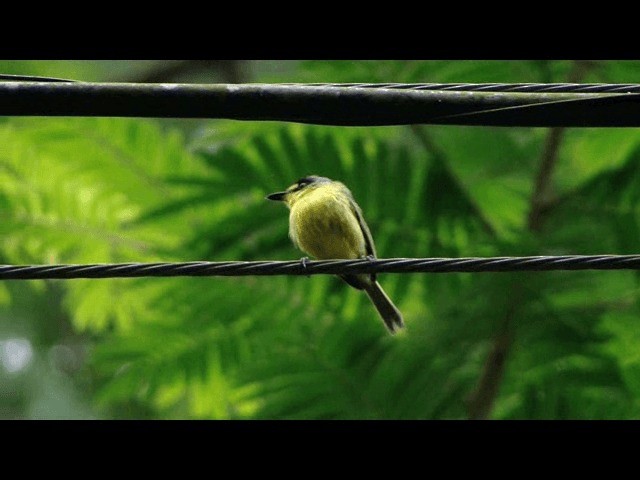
289, 186, 366, 260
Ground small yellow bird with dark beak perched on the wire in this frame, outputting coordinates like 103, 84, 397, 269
267, 175, 404, 333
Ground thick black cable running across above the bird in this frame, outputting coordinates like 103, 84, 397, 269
0, 81, 640, 127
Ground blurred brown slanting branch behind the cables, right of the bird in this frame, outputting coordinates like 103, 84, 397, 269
467, 61, 597, 419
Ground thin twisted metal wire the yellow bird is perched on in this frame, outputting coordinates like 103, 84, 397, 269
0, 255, 640, 280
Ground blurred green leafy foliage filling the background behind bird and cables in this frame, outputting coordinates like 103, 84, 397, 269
0, 61, 640, 419
